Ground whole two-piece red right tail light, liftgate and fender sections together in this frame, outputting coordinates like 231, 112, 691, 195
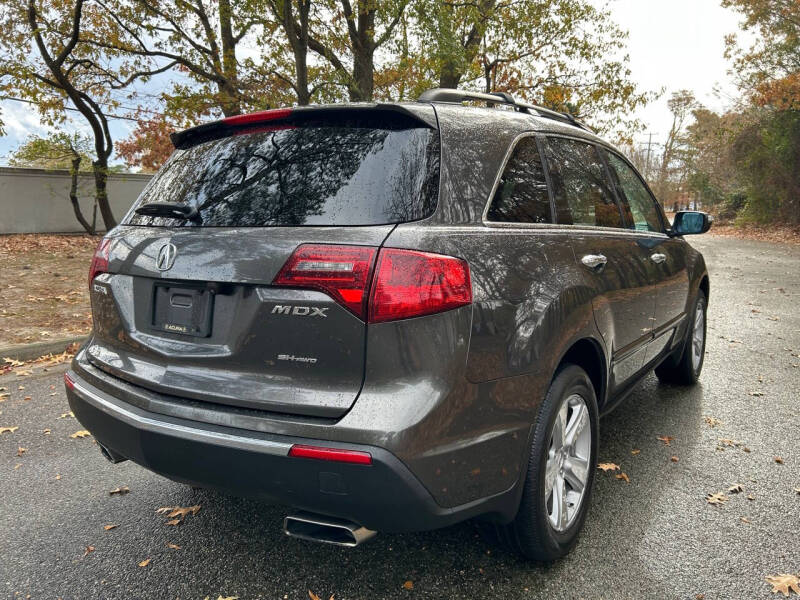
273, 244, 472, 323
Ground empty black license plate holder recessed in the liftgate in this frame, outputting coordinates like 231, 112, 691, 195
152, 283, 214, 337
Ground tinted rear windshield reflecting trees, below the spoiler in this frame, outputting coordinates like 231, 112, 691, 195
126, 118, 439, 227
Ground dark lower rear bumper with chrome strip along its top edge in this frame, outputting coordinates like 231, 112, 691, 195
67, 371, 519, 532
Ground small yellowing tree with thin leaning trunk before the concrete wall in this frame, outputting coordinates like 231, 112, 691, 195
8, 133, 96, 235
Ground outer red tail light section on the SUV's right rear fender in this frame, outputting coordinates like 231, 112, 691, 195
369, 248, 472, 323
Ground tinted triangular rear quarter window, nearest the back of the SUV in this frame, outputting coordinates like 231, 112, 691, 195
487, 137, 552, 223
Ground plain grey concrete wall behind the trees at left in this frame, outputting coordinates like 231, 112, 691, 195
0, 167, 152, 234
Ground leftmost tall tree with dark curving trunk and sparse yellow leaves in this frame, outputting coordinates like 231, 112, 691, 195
0, 0, 139, 229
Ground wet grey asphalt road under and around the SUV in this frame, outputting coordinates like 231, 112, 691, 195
0, 237, 800, 600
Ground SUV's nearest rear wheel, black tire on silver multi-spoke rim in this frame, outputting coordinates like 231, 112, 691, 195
497, 364, 598, 562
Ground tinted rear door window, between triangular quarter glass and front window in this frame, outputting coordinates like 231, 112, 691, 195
547, 138, 623, 227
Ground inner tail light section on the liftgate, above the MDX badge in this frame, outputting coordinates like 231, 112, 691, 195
272, 244, 377, 320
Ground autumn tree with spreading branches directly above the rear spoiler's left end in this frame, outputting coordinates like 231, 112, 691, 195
88, 0, 286, 122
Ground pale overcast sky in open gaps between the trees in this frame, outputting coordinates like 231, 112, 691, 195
0, 0, 752, 164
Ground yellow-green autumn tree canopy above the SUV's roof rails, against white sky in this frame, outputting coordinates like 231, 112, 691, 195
416, 0, 654, 140
